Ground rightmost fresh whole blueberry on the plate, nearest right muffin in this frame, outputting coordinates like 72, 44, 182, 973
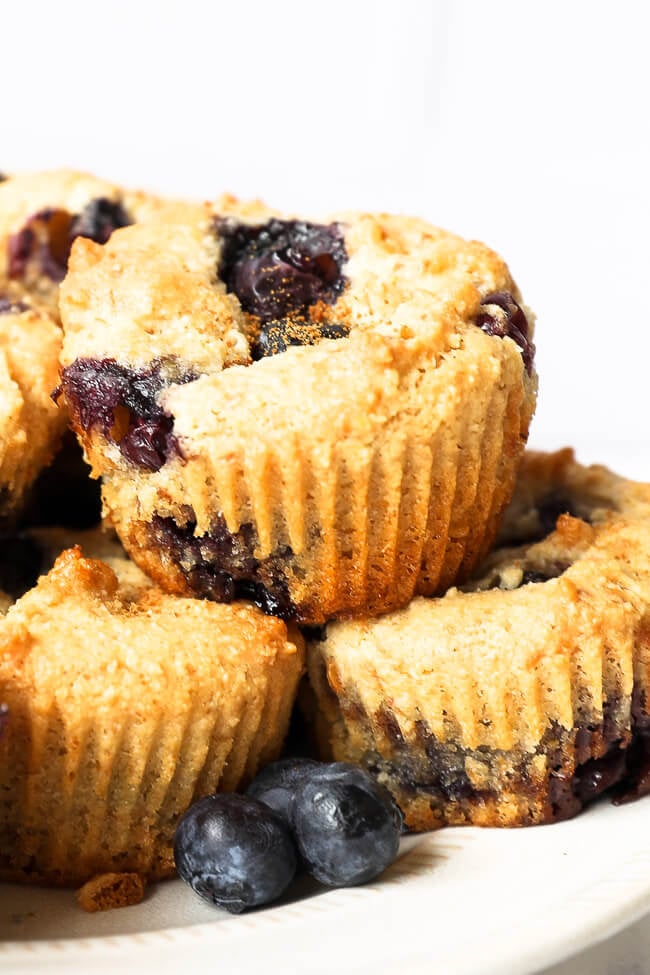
291, 762, 403, 887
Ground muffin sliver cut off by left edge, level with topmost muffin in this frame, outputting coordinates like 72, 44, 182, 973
0, 293, 66, 523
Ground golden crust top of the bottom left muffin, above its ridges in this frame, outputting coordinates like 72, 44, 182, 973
0, 547, 299, 712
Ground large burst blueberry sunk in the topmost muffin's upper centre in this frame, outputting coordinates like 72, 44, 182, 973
216, 217, 347, 324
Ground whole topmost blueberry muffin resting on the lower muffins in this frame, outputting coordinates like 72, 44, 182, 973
61, 198, 536, 624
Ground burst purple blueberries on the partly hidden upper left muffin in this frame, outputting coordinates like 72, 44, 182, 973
8, 197, 132, 284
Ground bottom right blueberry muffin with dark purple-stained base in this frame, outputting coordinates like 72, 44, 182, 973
304, 451, 650, 830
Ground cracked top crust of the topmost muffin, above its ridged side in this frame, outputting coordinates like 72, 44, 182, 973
60, 197, 535, 480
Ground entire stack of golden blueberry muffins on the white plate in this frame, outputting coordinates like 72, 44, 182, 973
0, 173, 650, 896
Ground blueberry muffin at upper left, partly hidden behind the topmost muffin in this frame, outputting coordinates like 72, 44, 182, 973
0, 169, 200, 316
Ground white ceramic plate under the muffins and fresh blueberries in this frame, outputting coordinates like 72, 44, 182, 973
0, 798, 650, 975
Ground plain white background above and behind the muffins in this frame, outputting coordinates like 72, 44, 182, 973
0, 0, 650, 971
